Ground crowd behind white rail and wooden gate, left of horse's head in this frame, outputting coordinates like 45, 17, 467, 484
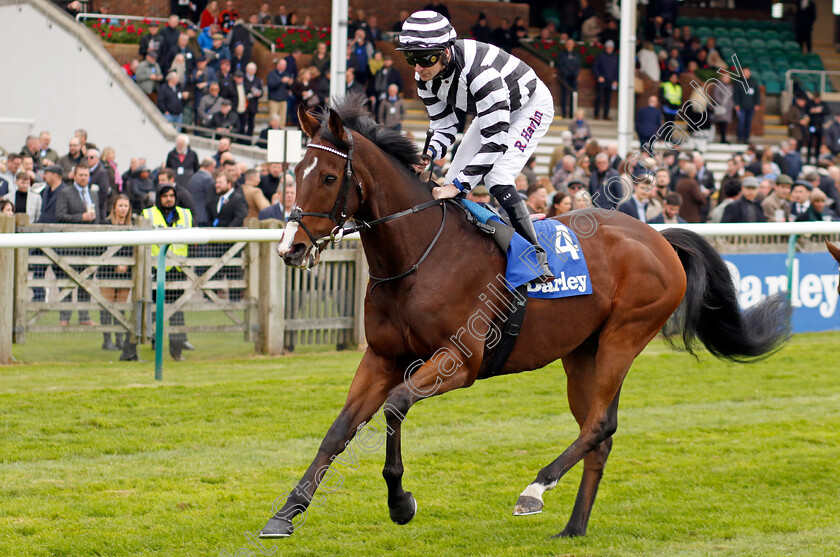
0, 129, 302, 360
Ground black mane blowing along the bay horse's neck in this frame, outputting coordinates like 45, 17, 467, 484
315, 93, 420, 167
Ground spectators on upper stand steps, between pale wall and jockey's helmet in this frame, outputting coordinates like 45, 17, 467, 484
109, 0, 416, 138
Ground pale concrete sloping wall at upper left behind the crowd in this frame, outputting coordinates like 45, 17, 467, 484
0, 0, 265, 170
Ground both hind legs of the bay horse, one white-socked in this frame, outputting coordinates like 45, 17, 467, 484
514, 334, 636, 535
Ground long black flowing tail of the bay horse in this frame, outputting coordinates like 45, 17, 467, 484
662, 228, 791, 362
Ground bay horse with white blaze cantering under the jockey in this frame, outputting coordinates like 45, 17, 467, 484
260, 100, 790, 538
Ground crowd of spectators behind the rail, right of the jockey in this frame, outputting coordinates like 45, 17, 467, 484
516, 128, 840, 223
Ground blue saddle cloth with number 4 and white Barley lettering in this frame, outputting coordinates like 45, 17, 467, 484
461, 199, 592, 298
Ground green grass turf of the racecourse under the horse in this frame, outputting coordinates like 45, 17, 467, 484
0, 333, 840, 556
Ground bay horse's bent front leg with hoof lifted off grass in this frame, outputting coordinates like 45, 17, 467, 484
382, 346, 480, 525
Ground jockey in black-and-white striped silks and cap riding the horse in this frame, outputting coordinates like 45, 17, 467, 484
397, 10, 554, 281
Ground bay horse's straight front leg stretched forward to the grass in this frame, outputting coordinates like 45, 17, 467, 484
260, 349, 403, 538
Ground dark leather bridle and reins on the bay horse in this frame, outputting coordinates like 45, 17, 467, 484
289, 126, 446, 291
